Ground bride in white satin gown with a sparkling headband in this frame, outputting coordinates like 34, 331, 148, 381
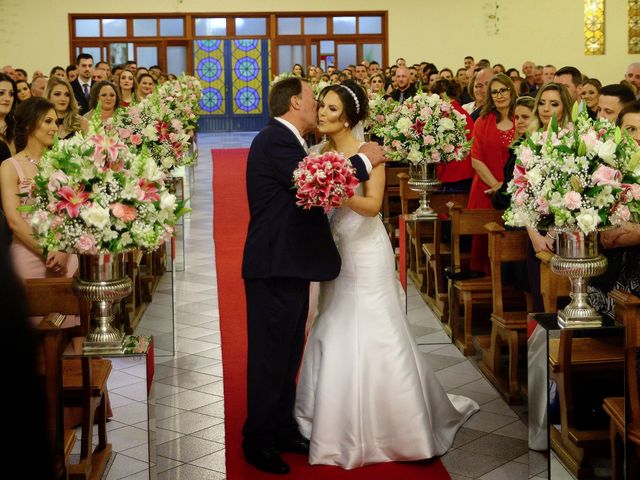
295, 80, 479, 469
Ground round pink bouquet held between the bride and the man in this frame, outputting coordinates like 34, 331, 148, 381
293, 152, 358, 213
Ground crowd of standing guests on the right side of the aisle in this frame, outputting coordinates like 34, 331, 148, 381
293, 56, 640, 316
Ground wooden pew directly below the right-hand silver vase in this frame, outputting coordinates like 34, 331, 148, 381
549, 318, 624, 479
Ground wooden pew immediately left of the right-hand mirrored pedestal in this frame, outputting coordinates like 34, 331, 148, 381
478, 222, 529, 404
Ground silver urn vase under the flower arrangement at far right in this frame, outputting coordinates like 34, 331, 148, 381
551, 231, 607, 328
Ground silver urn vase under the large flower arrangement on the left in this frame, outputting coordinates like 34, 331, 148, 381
73, 252, 132, 353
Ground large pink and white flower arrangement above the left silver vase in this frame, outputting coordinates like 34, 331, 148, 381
23, 130, 188, 254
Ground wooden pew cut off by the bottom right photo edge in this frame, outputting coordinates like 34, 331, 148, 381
603, 290, 640, 480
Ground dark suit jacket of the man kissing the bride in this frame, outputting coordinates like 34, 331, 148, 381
242, 119, 368, 281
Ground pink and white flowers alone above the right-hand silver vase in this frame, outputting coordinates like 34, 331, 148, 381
504, 114, 640, 234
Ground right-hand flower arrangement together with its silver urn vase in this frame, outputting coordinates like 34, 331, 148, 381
504, 114, 640, 328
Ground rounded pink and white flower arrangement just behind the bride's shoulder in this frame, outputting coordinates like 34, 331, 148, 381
379, 92, 471, 165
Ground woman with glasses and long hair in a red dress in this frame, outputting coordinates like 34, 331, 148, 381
468, 73, 518, 275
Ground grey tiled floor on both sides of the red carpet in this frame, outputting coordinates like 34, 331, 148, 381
95, 133, 547, 480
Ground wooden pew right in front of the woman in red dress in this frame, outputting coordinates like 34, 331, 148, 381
448, 205, 502, 355
